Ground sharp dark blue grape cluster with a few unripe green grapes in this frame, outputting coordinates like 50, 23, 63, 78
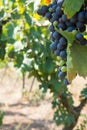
37, 0, 87, 85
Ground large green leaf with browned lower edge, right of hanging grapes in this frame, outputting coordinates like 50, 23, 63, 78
67, 42, 87, 80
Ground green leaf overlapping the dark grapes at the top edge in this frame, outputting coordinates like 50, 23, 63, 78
63, 0, 84, 18
